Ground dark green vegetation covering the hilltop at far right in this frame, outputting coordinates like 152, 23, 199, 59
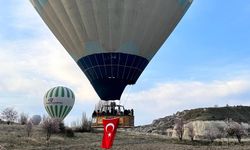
183, 106, 250, 123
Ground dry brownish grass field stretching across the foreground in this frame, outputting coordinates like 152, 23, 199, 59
0, 125, 250, 150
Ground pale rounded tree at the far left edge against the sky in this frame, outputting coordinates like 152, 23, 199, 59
1, 108, 18, 124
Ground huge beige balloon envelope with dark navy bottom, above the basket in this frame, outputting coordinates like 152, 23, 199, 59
30, 0, 192, 101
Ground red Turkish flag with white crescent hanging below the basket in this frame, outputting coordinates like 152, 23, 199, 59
101, 118, 119, 149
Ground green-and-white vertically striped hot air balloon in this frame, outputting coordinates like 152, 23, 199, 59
44, 86, 75, 120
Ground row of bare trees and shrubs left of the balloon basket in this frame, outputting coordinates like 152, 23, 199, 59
0, 108, 92, 143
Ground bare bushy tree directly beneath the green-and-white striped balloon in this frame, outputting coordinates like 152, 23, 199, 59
42, 116, 60, 141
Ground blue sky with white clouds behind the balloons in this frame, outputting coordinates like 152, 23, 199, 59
0, 0, 250, 125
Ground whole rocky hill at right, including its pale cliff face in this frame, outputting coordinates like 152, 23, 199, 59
132, 106, 250, 138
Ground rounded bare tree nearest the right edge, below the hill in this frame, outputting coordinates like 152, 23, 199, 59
225, 121, 248, 143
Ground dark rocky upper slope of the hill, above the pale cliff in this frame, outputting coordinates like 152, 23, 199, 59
133, 106, 250, 134
